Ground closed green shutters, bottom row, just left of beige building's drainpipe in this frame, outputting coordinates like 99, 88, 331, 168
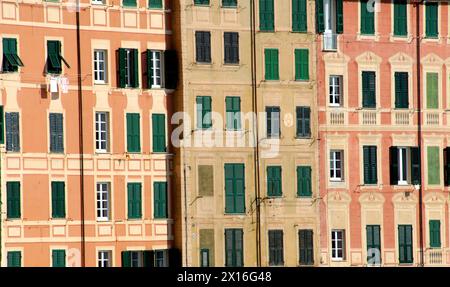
225, 228, 244, 267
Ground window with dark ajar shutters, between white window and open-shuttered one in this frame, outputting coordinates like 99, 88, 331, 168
118, 48, 139, 88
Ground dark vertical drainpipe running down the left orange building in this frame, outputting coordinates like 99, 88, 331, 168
76, 0, 86, 267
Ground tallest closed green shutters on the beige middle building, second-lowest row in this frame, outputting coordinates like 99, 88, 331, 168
225, 163, 245, 214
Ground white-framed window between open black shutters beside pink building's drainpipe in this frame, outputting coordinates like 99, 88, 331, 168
389, 147, 420, 185
